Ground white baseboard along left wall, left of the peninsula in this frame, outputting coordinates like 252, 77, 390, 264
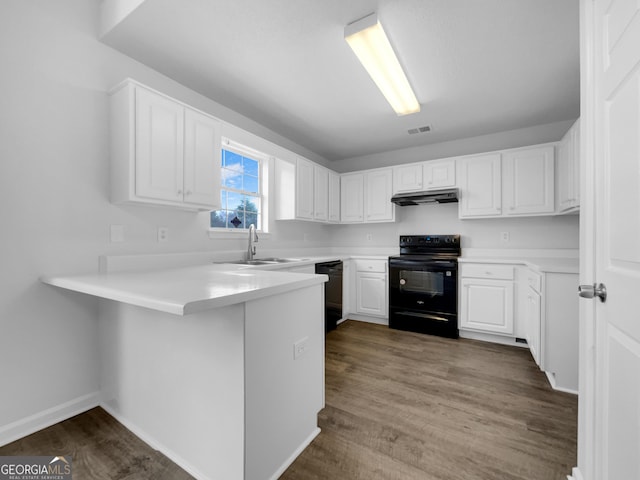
0, 392, 100, 447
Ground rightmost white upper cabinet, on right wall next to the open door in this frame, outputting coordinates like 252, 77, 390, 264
557, 120, 580, 213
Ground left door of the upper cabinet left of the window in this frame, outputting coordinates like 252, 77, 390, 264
135, 87, 184, 203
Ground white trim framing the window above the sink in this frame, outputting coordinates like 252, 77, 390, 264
207, 137, 271, 239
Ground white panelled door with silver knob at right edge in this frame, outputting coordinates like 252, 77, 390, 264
579, 0, 640, 480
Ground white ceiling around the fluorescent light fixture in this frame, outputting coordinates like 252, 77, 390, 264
102, 0, 579, 160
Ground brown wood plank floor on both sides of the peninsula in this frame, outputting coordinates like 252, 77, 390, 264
0, 321, 577, 480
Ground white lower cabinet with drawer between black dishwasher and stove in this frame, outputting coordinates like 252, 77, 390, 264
355, 259, 389, 318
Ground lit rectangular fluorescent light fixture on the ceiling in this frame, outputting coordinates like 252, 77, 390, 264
344, 13, 420, 115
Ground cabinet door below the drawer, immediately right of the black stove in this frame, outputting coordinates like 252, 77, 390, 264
460, 278, 513, 335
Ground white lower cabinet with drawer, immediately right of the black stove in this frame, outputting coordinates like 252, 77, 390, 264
460, 263, 514, 336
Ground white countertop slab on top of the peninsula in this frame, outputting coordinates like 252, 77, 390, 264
41, 260, 327, 315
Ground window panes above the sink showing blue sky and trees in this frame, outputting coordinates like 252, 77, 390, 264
210, 146, 263, 230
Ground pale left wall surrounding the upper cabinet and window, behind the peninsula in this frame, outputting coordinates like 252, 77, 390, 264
0, 0, 330, 436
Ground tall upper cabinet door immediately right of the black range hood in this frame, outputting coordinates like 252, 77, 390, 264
459, 153, 502, 218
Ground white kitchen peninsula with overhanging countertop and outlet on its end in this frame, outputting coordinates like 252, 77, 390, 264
42, 264, 327, 480
